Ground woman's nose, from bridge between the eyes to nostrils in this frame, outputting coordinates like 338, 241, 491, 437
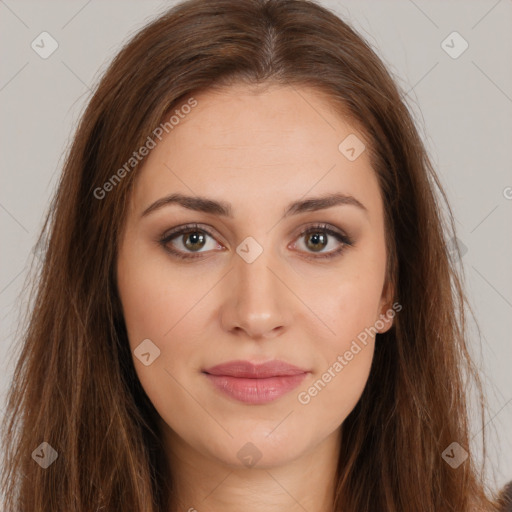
221, 250, 292, 340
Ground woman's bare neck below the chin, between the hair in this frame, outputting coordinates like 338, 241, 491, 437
163, 425, 340, 512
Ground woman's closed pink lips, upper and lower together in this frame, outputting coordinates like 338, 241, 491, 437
203, 360, 310, 405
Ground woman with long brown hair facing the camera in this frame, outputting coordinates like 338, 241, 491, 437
3, 0, 503, 512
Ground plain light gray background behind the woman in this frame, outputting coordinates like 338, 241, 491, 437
0, 0, 512, 494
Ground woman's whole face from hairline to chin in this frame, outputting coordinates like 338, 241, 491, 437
117, 85, 392, 467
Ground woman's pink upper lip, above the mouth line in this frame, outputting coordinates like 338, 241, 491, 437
203, 360, 308, 379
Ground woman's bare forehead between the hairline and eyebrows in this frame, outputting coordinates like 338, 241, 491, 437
133, 85, 380, 218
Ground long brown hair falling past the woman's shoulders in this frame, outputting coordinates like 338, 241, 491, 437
2, 0, 504, 512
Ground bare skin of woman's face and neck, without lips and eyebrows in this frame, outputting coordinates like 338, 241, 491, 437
117, 84, 392, 512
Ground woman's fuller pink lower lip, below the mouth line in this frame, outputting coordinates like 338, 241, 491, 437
206, 373, 307, 405
